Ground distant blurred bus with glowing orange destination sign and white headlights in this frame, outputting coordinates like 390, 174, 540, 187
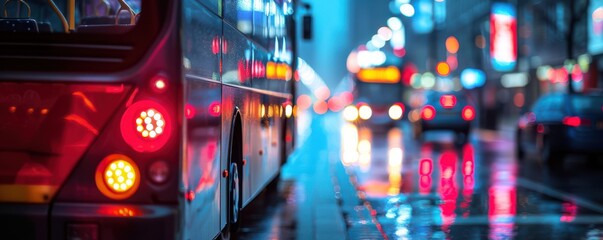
344, 58, 405, 126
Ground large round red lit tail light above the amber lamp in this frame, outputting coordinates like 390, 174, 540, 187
120, 100, 172, 152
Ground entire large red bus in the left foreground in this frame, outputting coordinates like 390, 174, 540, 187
0, 0, 296, 239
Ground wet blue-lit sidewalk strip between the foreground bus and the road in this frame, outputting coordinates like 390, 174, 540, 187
281, 117, 383, 240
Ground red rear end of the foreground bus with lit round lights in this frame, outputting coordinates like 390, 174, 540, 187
0, 0, 182, 239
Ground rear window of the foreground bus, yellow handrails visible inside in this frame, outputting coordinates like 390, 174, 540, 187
0, 0, 143, 34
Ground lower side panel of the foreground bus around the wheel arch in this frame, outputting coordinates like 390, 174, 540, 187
222, 85, 286, 208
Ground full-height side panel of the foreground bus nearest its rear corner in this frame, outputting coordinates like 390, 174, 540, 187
182, 1, 223, 239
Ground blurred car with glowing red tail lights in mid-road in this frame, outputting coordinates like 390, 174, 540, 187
412, 91, 476, 144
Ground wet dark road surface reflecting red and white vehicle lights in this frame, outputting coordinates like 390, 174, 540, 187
240, 111, 603, 239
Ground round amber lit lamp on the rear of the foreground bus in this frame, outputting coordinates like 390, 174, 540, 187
95, 154, 141, 200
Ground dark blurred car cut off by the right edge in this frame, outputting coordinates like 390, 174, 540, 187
516, 93, 603, 168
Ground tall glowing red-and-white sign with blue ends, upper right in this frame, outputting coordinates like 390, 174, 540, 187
490, 3, 517, 72
